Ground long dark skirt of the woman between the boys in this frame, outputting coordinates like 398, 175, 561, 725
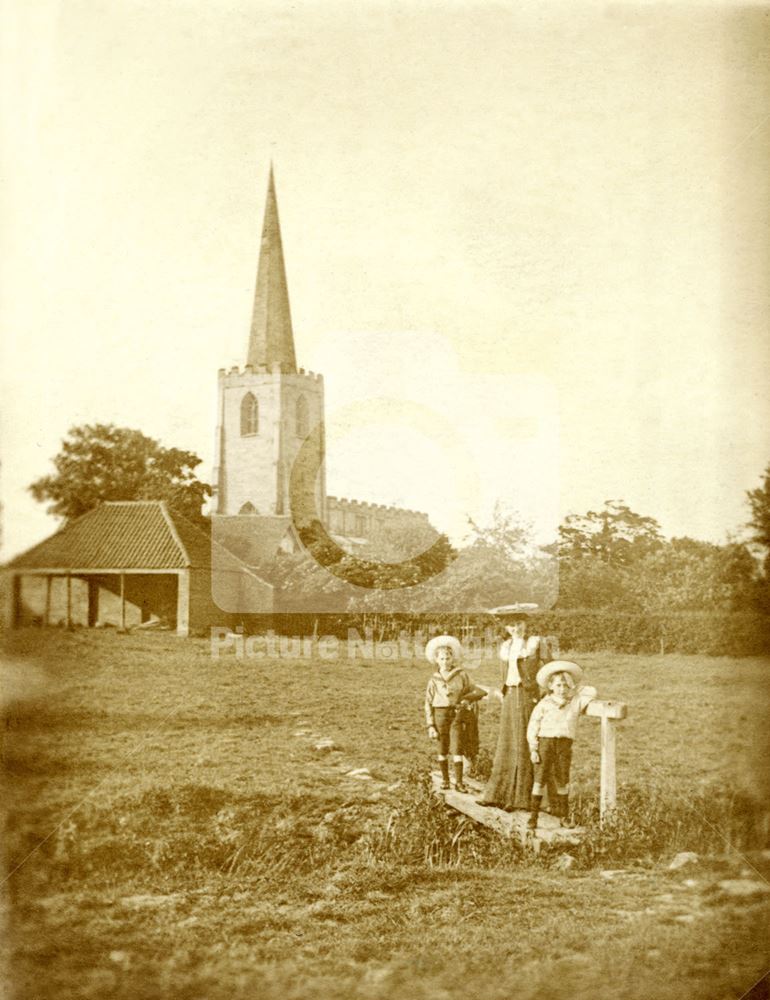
479, 685, 535, 810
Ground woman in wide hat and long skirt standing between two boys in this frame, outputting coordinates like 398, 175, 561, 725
479, 613, 553, 810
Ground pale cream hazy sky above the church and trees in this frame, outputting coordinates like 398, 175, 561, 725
0, 0, 770, 557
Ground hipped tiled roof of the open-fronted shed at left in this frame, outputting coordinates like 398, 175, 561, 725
8, 500, 196, 570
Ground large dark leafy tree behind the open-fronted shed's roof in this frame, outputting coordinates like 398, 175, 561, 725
29, 424, 211, 524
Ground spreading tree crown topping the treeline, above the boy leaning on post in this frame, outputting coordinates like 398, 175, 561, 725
558, 500, 663, 566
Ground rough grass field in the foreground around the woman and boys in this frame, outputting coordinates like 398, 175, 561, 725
3, 630, 770, 1000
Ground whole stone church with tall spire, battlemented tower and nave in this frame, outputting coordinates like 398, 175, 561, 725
212, 167, 429, 562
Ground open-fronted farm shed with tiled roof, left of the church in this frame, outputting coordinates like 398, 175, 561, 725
3, 500, 273, 636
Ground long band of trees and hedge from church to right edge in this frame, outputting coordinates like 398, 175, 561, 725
230, 494, 770, 659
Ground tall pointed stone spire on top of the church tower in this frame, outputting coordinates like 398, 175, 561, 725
246, 163, 297, 372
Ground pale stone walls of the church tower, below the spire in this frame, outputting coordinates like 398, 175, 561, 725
214, 365, 326, 520
